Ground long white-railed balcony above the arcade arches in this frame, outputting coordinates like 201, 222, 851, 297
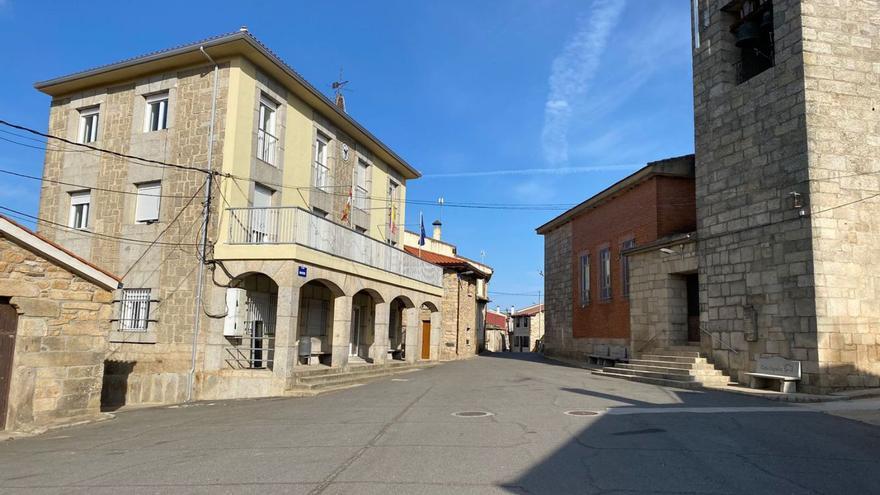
226, 207, 443, 287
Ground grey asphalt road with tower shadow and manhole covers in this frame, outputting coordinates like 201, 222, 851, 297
0, 354, 880, 495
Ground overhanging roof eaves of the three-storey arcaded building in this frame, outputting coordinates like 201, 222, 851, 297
34, 28, 421, 179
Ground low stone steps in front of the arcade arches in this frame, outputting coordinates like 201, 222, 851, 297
285, 361, 437, 397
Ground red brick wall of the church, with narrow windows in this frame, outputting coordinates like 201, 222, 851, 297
571, 177, 696, 339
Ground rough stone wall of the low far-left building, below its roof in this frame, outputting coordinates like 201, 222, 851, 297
0, 237, 113, 430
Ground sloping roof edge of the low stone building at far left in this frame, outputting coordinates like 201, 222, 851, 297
0, 215, 122, 290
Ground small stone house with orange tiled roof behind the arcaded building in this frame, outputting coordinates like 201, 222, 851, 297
404, 220, 493, 361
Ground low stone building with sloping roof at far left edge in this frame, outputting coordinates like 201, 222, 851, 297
0, 216, 119, 431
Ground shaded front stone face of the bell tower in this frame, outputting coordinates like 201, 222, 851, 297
694, 0, 820, 391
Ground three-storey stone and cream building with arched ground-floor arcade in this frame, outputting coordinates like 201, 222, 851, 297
36, 28, 446, 406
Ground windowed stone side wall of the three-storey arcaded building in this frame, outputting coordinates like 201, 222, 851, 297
40, 64, 229, 404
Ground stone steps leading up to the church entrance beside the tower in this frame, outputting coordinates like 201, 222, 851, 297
593, 346, 730, 389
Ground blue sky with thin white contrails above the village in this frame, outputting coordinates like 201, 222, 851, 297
0, 0, 694, 308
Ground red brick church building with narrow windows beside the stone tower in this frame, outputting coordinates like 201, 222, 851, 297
537, 155, 696, 359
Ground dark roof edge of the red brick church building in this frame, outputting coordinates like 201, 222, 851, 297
535, 155, 694, 235
